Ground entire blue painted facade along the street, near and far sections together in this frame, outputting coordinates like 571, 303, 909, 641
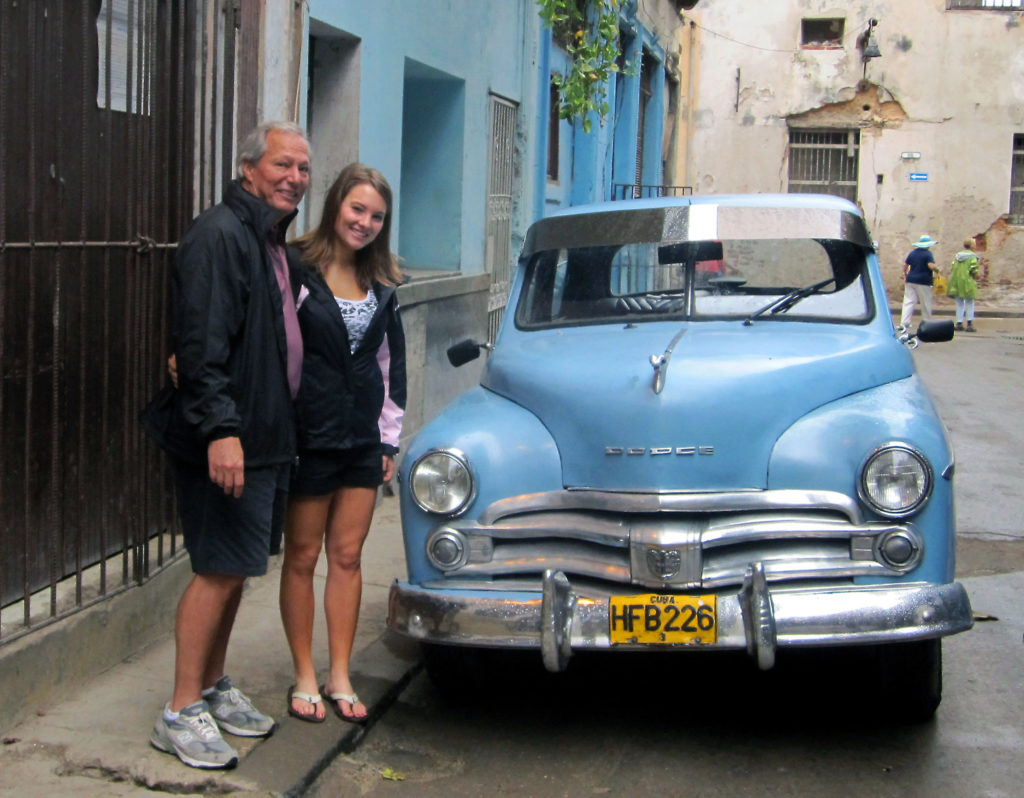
309, 0, 665, 238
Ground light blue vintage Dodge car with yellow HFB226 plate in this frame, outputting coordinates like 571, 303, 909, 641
388, 195, 972, 720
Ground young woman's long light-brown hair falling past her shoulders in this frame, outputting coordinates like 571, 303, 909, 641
292, 163, 402, 291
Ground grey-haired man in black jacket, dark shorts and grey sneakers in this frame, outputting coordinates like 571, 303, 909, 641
147, 122, 309, 767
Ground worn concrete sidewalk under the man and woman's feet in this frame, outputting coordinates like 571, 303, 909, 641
0, 497, 419, 798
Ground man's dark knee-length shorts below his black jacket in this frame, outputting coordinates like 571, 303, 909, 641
173, 461, 292, 577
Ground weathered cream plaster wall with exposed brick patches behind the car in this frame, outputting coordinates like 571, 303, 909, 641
688, 0, 1024, 305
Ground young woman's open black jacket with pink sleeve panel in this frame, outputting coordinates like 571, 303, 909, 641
297, 269, 406, 455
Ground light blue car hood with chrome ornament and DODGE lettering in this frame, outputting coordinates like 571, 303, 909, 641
482, 322, 912, 491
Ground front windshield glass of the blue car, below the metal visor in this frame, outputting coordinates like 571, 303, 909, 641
516, 239, 872, 329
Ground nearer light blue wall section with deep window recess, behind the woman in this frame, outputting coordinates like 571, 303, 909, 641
309, 0, 541, 274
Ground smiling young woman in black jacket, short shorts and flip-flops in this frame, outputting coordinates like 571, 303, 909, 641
281, 164, 406, 722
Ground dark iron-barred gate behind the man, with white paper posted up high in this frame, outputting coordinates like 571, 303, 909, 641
0, 0, 259, 641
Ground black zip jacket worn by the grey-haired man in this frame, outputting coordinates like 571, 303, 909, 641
142, 180, 304, 467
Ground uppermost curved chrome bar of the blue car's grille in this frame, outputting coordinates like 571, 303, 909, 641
478, 488, 863, 527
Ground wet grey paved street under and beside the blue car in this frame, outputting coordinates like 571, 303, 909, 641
310, 319, 1024, 798
